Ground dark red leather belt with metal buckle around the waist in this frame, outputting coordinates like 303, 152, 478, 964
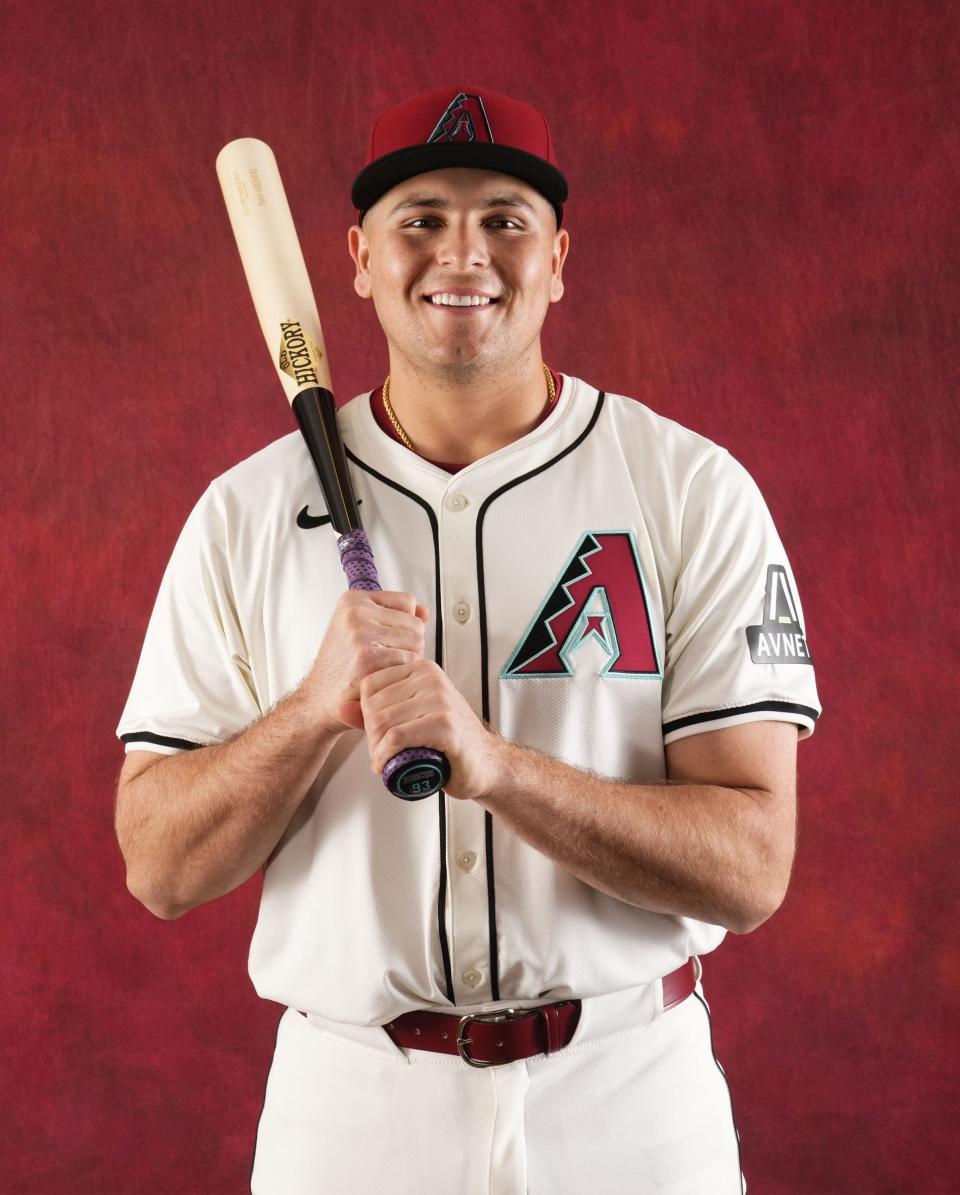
384, 958, 697, 1066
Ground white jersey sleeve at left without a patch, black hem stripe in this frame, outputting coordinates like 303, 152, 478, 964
116, 482, 262, 755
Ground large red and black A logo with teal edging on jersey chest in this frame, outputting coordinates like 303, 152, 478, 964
500, 531, 660, 680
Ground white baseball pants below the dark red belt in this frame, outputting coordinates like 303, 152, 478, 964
251, 965, 746, 1195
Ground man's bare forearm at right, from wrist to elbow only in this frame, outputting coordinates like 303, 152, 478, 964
478, 740, 789, 932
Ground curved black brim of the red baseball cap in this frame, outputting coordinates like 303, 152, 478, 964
350, 141, 567, 225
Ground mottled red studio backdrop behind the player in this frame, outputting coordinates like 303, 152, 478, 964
0, 0, 960, 1195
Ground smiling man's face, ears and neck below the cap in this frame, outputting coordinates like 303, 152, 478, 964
349, 167, 569, 461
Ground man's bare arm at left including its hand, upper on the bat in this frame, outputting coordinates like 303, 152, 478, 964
115, 590, 428, 919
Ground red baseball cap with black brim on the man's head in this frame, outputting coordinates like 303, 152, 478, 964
351, 87, 567, 227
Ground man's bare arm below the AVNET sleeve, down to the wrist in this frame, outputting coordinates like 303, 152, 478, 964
477, 722, 797, 933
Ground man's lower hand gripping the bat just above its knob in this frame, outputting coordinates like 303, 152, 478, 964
360, 660, 509, 801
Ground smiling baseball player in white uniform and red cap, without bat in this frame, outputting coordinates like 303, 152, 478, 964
117, 87, 820, 1195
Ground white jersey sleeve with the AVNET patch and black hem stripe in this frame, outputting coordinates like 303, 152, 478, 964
662, 447, 821, 743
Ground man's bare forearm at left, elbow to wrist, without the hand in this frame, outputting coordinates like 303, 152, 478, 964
116, 691, 338, 918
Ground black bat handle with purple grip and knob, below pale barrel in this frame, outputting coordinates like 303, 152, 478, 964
293, 386, 450, 801
